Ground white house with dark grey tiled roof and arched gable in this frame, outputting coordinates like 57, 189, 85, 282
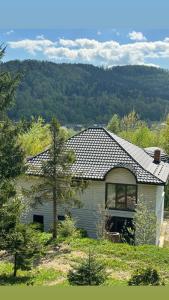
23, 128, 169, 244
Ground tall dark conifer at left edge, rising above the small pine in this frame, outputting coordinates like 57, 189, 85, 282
0, 49, 24, 207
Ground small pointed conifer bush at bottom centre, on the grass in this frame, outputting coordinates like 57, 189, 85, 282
68, 251, 107, 286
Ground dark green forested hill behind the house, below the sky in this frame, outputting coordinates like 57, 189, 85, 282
0, 60, 169, 124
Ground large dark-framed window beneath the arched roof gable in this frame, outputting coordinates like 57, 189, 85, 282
106, 183, 137, 210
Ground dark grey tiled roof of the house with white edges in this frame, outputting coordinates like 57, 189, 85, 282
27, 128, 169, 184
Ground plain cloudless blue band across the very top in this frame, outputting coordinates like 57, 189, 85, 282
0, 0, 169, 29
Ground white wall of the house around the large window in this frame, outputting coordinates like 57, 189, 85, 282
17, 168, 163, 243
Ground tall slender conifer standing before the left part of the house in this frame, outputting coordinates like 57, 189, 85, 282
30, 118, 85, 238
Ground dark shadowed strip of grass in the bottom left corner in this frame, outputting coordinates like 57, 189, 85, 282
0, 274, 34, 286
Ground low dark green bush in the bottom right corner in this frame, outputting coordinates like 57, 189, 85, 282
128, 268, 164, 285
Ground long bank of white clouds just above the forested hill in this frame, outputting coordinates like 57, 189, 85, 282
6, 37, 169, 67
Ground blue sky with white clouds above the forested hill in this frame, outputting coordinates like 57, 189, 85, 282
0, 0, 169, 69
